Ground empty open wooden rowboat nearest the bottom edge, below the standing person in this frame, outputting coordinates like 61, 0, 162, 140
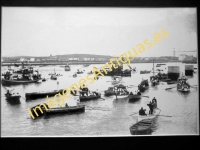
130, 119, 153, 135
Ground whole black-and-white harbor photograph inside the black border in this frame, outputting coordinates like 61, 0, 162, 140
1, 7, 199, 137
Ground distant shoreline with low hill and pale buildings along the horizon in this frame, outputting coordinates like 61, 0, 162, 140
2, 54, 197, 63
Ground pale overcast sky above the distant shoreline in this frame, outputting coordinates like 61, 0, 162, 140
1, 7, 197, 57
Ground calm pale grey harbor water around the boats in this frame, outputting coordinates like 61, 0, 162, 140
1, 63, 199, 137
